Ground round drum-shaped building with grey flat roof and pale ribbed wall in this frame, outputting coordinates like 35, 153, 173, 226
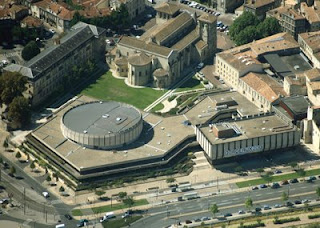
61, 101, 143, 149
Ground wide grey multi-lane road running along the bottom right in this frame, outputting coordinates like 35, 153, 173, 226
131, 180, 320, 228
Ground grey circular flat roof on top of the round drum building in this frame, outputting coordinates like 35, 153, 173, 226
62, 101, 141, 135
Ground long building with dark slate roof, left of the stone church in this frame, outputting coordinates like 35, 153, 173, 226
4, 22, 105, 106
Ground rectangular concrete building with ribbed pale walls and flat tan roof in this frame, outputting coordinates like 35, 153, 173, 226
196, 113, 300, 163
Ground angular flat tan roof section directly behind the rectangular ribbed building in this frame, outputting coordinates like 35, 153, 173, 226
185, 91, 261, 125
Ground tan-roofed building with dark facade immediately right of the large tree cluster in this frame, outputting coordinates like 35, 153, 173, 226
267, 5, 308, 40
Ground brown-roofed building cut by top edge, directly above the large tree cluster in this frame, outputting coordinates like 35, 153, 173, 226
243, 0, 281, 19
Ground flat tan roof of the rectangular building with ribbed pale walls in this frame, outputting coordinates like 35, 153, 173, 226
200, 115, 294, 144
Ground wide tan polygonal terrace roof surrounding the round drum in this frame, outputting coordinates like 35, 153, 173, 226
32, 96, 194, 170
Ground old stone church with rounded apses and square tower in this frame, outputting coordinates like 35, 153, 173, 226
113, 3, 217, 88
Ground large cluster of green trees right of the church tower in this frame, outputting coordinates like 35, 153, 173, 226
229, 12, 281, 45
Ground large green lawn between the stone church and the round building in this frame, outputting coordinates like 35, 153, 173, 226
81, 71, 166, 109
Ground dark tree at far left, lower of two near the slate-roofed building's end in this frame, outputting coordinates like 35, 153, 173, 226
8, 97, 31, 127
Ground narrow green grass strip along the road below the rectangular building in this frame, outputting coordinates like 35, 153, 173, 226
236, 169, 320, 188
